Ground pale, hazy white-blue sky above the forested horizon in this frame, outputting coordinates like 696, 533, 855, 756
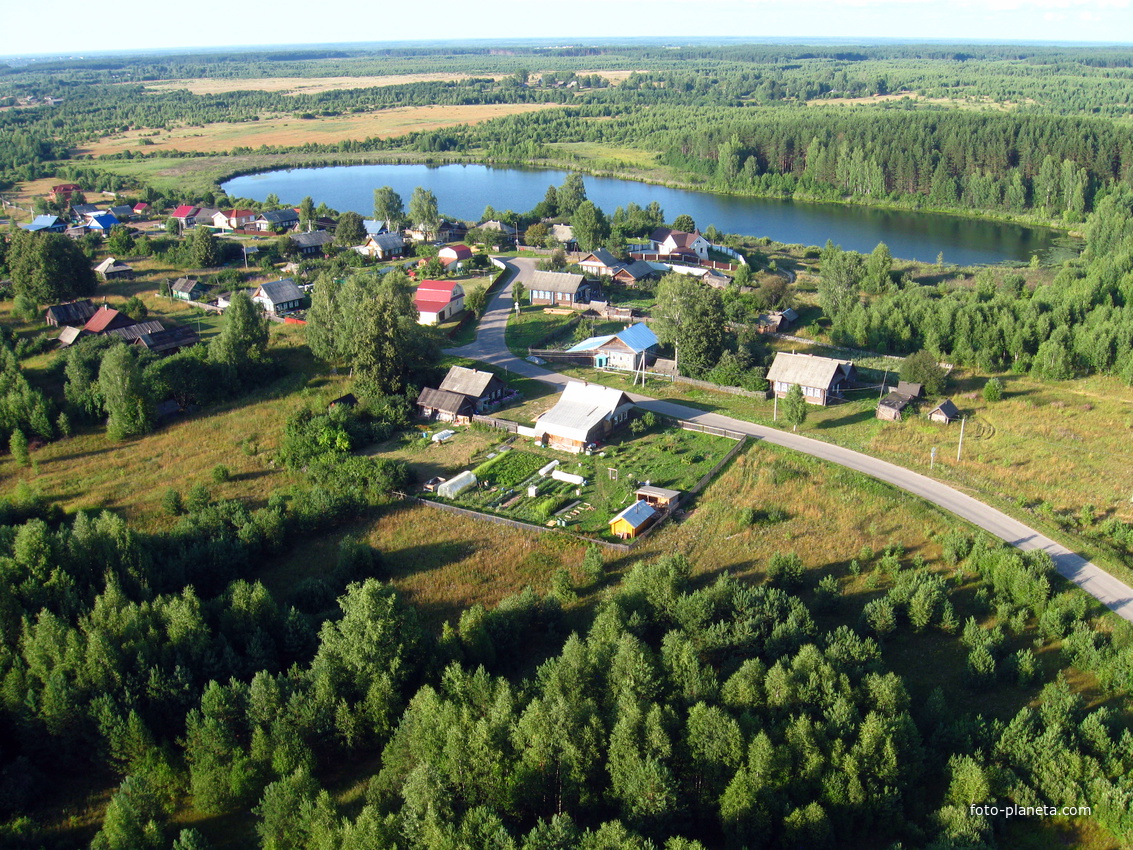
0, 0, 1133, 57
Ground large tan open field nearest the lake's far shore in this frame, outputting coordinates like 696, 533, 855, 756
76, 103, 555, 156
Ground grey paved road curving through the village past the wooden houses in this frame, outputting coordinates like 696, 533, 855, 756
449, 258, 1133, 621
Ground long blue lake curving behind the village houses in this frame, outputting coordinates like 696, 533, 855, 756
223, 164, 1057, 265
